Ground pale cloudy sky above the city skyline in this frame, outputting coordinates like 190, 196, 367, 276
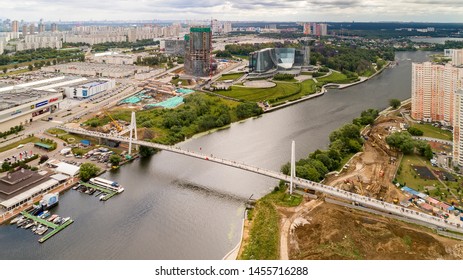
0, 0, 463, 22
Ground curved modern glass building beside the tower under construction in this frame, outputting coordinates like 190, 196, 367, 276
249, 47, 310, 73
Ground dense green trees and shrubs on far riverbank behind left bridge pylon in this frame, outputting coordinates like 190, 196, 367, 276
84, 93, 262, 145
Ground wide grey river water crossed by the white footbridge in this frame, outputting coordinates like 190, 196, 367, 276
0, 52, 436, 259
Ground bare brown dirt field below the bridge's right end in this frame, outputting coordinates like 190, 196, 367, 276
289, 203, 463, 260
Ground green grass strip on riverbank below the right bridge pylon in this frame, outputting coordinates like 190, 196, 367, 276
239, 188, 302, 260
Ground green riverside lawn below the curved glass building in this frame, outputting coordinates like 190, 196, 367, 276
215, 80, 317, 105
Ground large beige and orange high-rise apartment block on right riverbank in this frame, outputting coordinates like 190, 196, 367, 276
411, 62, 463, 126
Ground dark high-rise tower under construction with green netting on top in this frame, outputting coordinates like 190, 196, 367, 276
184, 27, 212, 77
